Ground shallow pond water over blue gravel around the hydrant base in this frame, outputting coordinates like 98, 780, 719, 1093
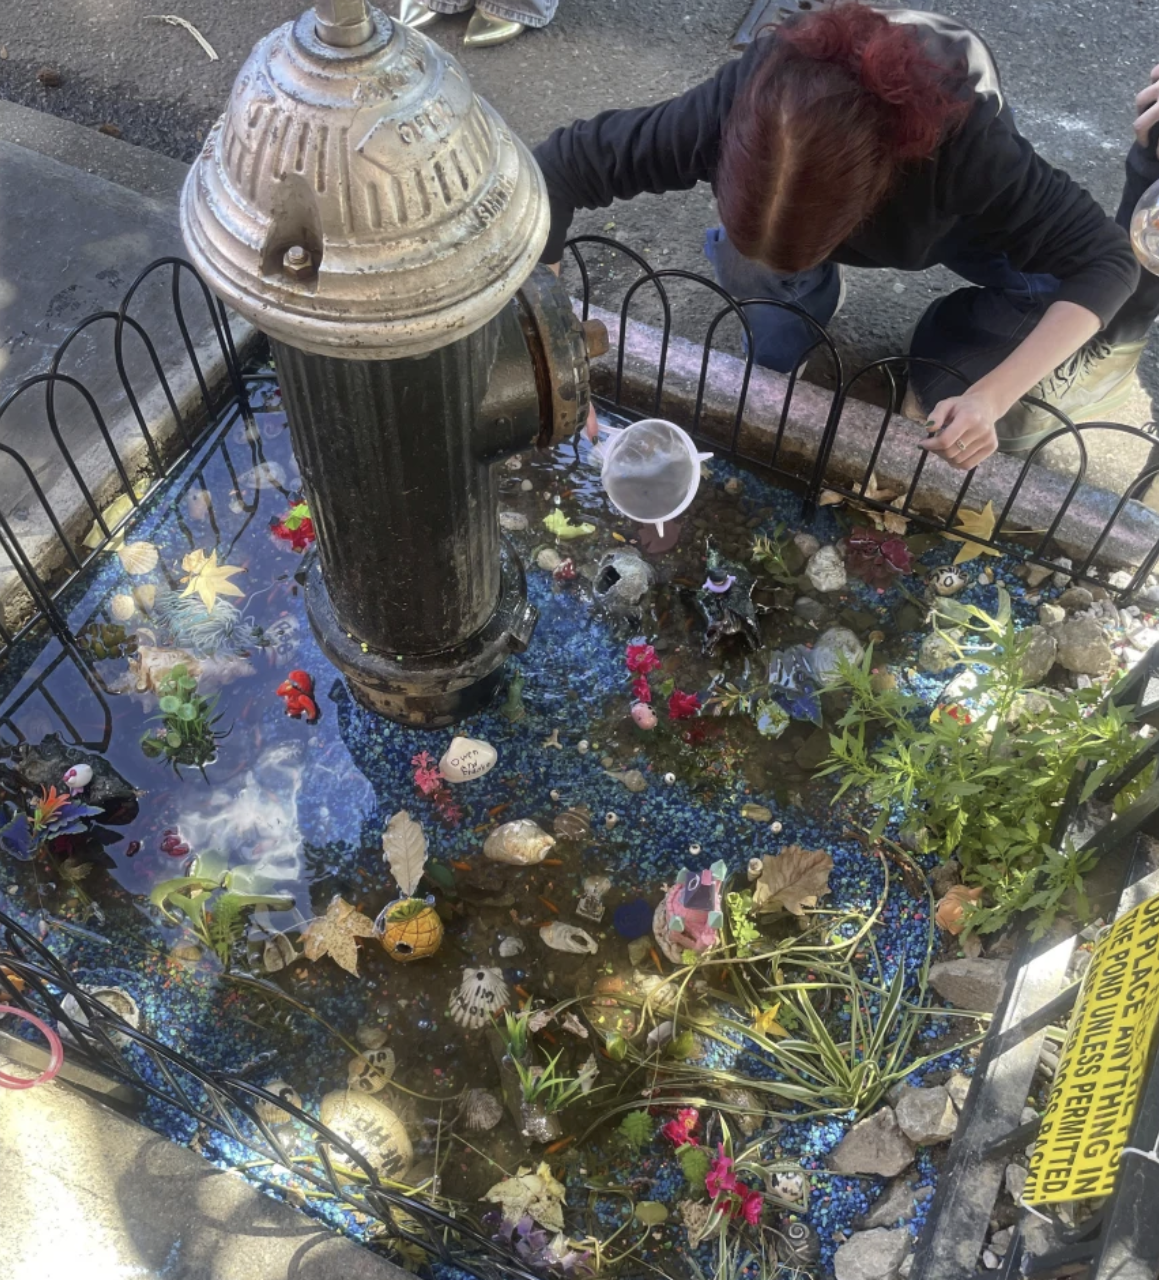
0, 383, 1137, 1275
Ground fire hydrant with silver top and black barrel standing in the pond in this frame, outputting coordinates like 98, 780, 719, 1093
181, 0, 607, 727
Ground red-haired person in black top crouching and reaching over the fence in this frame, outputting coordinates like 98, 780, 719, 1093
535, 0, 1154, 470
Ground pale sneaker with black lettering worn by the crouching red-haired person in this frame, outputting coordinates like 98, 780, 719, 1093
998, 338, 1146, 452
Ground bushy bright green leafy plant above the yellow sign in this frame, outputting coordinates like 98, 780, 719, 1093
821, 591, 1136, 936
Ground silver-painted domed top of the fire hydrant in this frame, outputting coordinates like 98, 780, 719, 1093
181, 0, 549, 360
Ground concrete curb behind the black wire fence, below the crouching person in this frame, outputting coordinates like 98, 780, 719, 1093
576, 303, 1159, 568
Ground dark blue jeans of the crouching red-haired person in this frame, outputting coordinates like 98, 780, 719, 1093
704, 227, 1059, 448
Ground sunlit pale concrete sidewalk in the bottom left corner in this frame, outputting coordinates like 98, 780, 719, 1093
0, 1057, 406, 1280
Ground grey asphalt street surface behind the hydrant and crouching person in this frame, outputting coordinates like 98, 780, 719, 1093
0, 0, 1159, 422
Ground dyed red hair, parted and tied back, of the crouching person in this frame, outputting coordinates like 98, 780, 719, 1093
716, 3, 971, 271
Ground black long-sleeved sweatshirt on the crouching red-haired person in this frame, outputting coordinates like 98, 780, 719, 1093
535, 9, 1140, 326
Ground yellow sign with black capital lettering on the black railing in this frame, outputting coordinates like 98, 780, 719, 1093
1022, 897, 1159, 1204
